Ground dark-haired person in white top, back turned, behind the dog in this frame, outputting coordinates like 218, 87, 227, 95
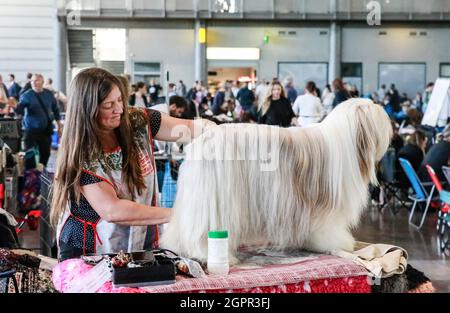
292, 81, 323, 126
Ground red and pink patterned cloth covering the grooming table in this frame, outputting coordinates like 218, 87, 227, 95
53, 256, 371, 293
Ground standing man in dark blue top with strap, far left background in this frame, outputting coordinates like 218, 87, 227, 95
16, 74, 62, 166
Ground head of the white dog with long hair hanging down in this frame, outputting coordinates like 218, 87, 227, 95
324, 98, 392, 183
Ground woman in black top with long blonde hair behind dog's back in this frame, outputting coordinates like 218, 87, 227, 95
258, 81, 295, 127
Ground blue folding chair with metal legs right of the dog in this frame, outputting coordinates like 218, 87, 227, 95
398, 158, 435, 229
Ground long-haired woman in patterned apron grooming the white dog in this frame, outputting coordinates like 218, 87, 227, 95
51, 68, 216, 260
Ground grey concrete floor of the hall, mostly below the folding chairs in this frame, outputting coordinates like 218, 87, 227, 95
20, 201, 450, 293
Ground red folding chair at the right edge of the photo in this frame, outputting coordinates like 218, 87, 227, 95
425, 164, 450, 249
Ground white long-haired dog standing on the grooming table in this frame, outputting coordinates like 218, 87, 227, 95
161, 99, 392, 263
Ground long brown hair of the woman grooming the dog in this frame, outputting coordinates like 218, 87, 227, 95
50, 68, 145, 225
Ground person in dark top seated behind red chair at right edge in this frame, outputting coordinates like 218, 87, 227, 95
419, 127, 450, 182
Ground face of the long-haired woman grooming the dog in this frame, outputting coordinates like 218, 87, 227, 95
97, 86, 123, 130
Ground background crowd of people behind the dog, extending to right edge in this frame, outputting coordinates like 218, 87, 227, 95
130, 74, 450, 195
